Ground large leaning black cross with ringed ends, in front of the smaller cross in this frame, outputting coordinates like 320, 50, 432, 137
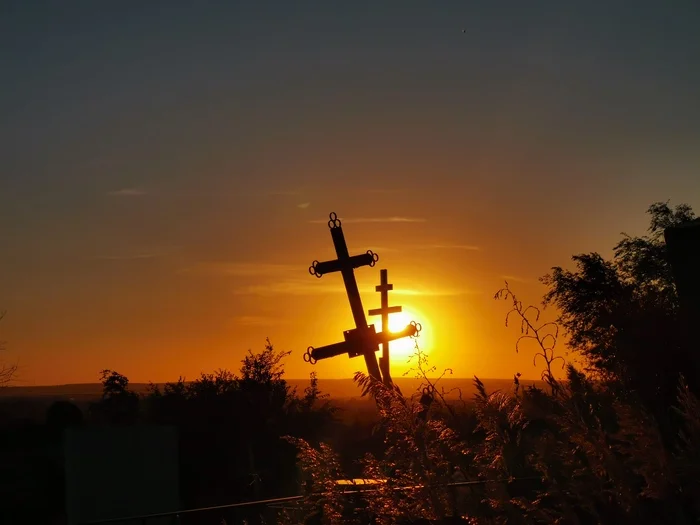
304, 213, 420, 381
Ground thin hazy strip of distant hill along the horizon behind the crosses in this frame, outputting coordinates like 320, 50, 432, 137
0, 377, 542, 403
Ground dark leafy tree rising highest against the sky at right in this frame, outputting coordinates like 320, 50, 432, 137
541, 202, 698, 432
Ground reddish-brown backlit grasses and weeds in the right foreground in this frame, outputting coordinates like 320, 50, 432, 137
288, 285, 700, 525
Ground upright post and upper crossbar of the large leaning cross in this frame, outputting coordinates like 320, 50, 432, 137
309, 213, 382, 381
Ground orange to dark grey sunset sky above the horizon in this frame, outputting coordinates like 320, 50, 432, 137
0, 0, 700, 385
